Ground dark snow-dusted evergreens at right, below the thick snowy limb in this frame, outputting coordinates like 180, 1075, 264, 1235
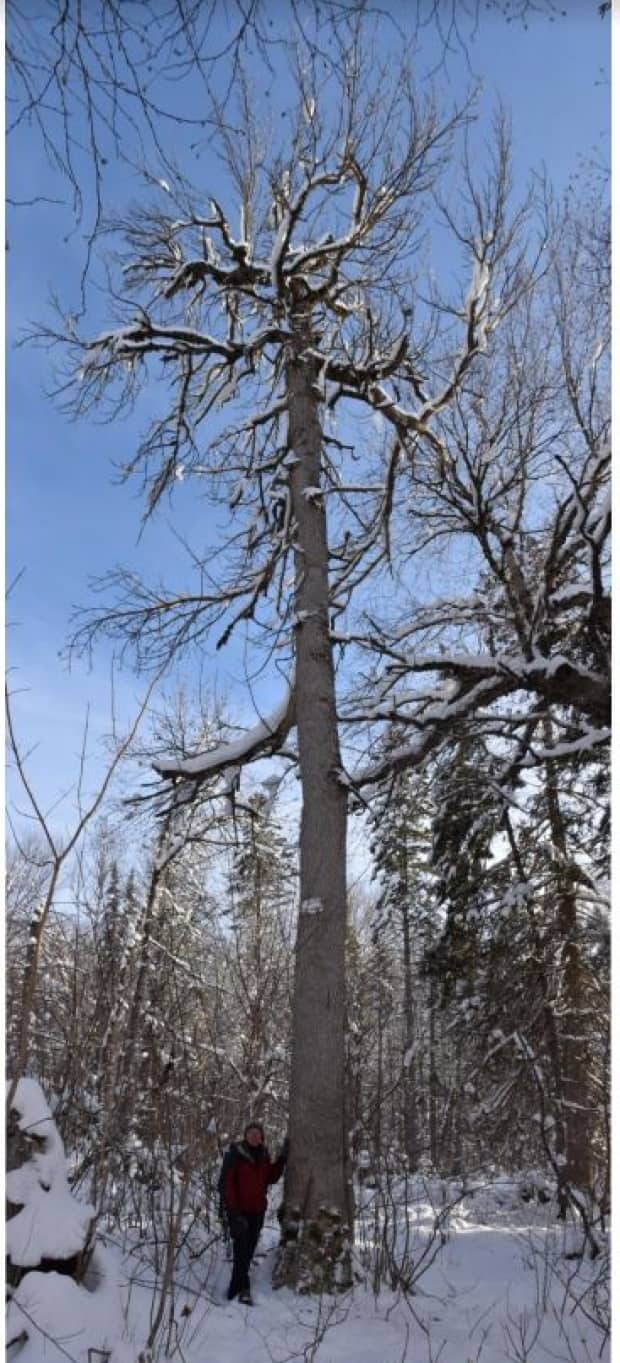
427, 719, 606, 1213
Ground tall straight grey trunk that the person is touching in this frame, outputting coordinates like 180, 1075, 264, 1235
274, 319, 350, 1292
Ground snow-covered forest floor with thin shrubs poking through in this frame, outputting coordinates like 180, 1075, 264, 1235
8, 1178, 609, 1363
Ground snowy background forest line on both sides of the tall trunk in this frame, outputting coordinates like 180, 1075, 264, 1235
7, 697, 609, 1224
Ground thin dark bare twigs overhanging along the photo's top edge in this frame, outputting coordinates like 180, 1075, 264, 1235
7, 0, 612, 255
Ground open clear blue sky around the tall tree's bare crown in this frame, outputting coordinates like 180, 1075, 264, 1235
7, 0, 609, 828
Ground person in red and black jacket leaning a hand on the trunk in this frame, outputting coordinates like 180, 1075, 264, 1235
222, 1120, 289, 1306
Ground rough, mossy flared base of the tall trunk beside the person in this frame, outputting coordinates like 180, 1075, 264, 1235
273, 1206, 353, 1296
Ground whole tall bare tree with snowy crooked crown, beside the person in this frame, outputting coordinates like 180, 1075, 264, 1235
40, 18, 527, 1285
